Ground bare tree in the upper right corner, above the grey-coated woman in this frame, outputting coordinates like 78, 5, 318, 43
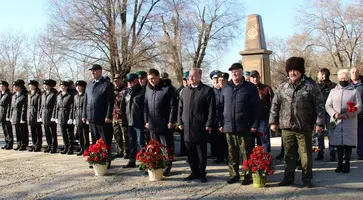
298, 0, 363, 68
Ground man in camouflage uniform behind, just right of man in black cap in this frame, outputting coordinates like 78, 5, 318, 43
112, 74, 129, 159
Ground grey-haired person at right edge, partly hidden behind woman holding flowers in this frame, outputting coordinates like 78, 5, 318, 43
350, 66, 363, 160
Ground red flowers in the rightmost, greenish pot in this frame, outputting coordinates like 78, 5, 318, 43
243, 146, 274, 176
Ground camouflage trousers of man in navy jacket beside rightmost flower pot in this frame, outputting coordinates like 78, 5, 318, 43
227, 132, 252, 179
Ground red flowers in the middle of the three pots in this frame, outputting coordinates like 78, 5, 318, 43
136, 139, 174, 170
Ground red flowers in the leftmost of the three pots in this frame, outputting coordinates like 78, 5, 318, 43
83, 138, 112, 165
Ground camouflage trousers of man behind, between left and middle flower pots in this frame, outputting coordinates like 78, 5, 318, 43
113, 122, 129, 155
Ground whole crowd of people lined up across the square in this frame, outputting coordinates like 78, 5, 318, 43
0, 57, 363, 187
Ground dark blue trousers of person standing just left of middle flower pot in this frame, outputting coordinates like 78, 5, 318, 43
127, 126, 145, 164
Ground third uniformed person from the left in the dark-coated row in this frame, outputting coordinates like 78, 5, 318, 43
28, 80, 43, 152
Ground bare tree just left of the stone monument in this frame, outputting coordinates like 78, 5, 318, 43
161, 0, 243, 84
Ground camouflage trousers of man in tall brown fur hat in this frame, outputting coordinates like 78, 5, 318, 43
282, 130, 313, 181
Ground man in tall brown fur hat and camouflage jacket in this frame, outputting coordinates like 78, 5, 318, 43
269, 57, 325, 188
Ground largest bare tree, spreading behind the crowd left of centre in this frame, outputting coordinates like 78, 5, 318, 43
46, 0, 160, 76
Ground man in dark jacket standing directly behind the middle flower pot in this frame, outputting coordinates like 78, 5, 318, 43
144, 69, 178, 176
